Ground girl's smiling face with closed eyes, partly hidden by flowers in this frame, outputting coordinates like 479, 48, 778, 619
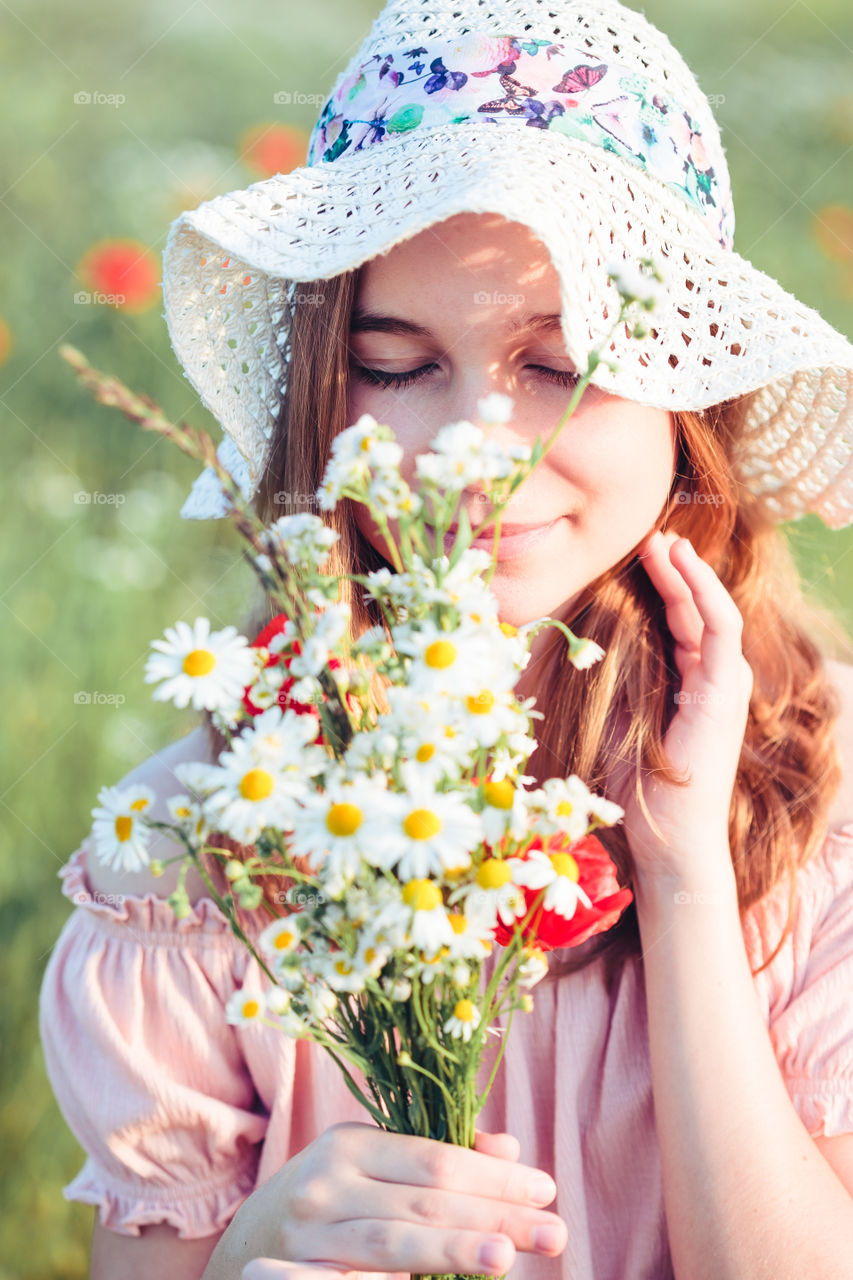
347, 212, 675, 626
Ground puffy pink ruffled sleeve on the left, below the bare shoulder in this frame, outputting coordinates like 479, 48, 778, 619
38, 841, 269, 1239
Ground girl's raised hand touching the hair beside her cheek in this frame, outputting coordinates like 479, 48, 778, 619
622, 530, 753, 886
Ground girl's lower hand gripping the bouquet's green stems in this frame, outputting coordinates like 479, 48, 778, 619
233, 1123, 567, 1280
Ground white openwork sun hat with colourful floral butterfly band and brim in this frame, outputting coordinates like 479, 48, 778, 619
163, 0, 853, 529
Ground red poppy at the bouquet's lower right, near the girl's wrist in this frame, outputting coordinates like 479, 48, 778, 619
494, 835, 634, 951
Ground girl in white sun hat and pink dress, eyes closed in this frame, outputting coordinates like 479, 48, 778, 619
41, 0, 853, 1280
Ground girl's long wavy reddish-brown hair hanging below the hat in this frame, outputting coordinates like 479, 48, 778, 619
194, 259, 850, 977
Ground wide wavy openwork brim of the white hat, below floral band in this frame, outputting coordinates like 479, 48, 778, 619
163, 122, 853, 529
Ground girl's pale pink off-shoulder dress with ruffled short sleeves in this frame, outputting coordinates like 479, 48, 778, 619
40, 822, 853, 1280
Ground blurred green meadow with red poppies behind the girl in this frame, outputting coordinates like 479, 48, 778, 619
0, 0, 853, 1280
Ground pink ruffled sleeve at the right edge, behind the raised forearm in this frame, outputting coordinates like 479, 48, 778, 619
744, 823, 853, 1137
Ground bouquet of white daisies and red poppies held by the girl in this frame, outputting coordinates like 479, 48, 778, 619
63, 264, 654, 1280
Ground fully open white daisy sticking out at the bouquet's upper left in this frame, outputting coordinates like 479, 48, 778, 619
143, 618, 260, 710
